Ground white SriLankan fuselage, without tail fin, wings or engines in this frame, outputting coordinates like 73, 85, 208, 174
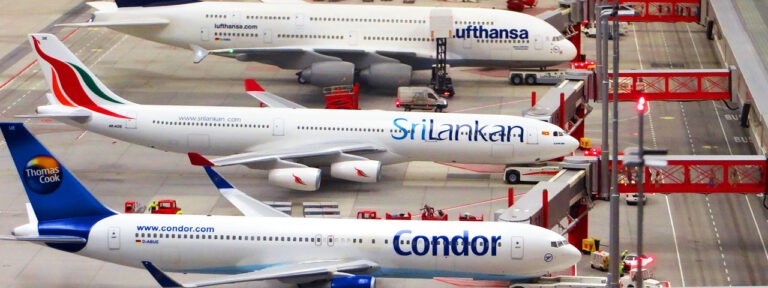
61, 104, 578, 165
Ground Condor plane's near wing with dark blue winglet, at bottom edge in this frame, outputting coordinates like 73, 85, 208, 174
141, 260, 379, 287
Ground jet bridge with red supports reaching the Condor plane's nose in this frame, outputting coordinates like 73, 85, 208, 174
496, 156, 598, 246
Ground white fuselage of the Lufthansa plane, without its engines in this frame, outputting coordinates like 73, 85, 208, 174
94, 2, 576, 69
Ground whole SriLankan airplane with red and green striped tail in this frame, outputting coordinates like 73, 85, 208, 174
21, 34, 578, 191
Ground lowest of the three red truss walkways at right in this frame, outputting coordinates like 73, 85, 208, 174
617, 155, 768, 193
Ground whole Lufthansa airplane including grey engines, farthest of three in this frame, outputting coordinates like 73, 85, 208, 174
63, 0, 576, 88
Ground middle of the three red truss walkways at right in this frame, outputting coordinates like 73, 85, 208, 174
608, 69, 731, 101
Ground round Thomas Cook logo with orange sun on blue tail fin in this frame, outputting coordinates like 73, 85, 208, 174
22, 155, 63, 195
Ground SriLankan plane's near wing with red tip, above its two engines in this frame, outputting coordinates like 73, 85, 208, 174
189, 142, 387, 170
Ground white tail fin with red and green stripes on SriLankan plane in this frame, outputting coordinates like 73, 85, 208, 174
29, 34, 134, 119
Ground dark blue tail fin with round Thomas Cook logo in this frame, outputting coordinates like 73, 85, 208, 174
0, 122, 116, 222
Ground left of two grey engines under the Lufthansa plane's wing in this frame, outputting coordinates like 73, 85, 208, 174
296, 61, 355, 87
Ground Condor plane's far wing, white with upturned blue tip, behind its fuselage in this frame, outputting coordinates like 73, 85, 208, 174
205, 166, 290, 217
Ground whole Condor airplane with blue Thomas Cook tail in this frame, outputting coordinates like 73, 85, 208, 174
0, 123, 581, 288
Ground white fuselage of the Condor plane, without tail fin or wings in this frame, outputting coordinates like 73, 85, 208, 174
77, 214, 580, 279
